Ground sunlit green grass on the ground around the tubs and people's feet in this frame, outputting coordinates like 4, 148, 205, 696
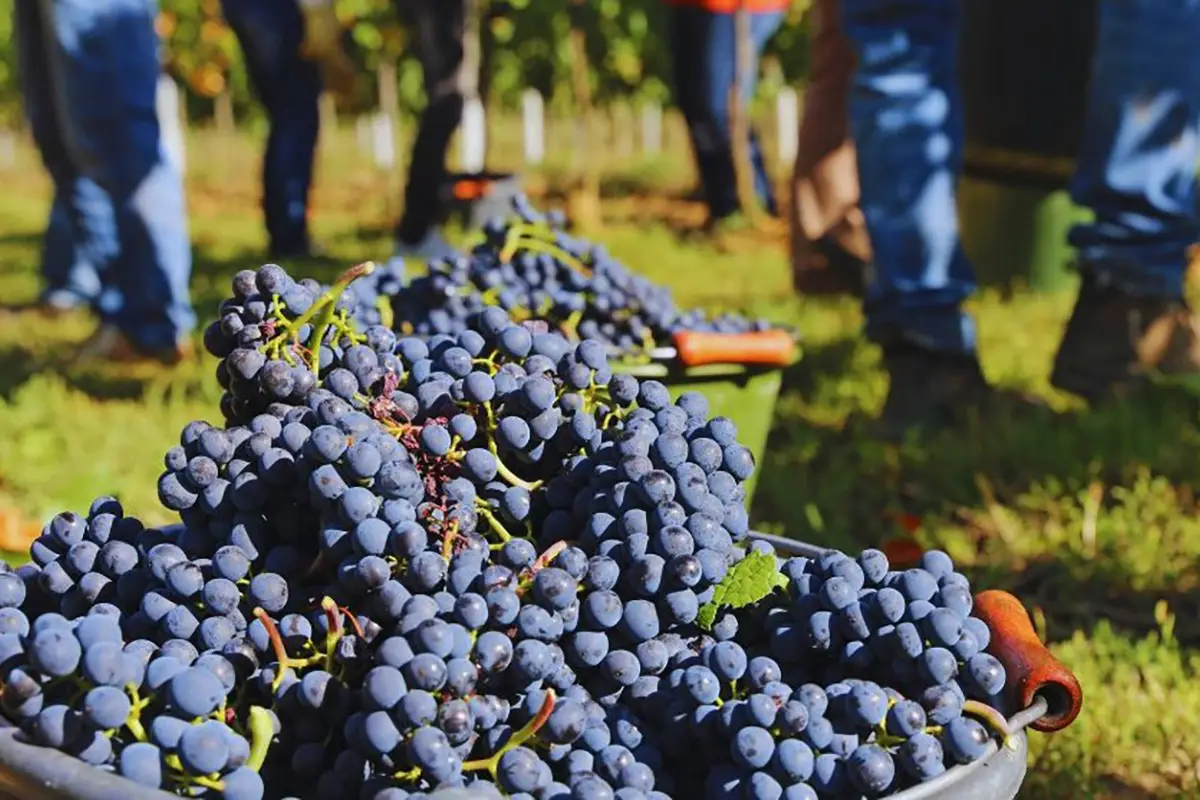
0, 128, 1200, 798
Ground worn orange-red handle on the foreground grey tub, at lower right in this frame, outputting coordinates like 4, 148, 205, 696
972, 589, 1084, 733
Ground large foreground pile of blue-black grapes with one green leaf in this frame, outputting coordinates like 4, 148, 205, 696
0, 265, 1004, 800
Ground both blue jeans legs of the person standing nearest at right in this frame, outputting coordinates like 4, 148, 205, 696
842, 0, 1200, 351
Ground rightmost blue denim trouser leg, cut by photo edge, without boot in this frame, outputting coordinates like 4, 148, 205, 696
1070, 0, 1200, 299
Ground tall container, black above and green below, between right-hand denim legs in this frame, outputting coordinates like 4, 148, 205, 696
959, 0, 1097, 291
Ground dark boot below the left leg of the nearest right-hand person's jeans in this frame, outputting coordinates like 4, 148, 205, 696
875, 343, 992, 441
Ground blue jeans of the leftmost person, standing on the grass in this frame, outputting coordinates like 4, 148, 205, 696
16, 0, 196, 349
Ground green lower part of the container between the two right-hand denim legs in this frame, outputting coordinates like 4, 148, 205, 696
959, 178, 1087, 291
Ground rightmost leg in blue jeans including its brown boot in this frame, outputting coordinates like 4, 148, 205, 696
1052, 0, 1200, 401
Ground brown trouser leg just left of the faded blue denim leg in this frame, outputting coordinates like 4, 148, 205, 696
788, 0, 871, 296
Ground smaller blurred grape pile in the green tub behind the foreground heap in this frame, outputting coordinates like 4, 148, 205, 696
379, 198, 772, 355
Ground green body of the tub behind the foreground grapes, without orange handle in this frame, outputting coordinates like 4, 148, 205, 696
613, 363, 784, 506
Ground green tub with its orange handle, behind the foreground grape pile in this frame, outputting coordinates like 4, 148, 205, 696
611, 330, 800, 506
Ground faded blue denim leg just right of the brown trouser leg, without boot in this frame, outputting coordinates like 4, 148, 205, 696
842, 0, 976, 351
